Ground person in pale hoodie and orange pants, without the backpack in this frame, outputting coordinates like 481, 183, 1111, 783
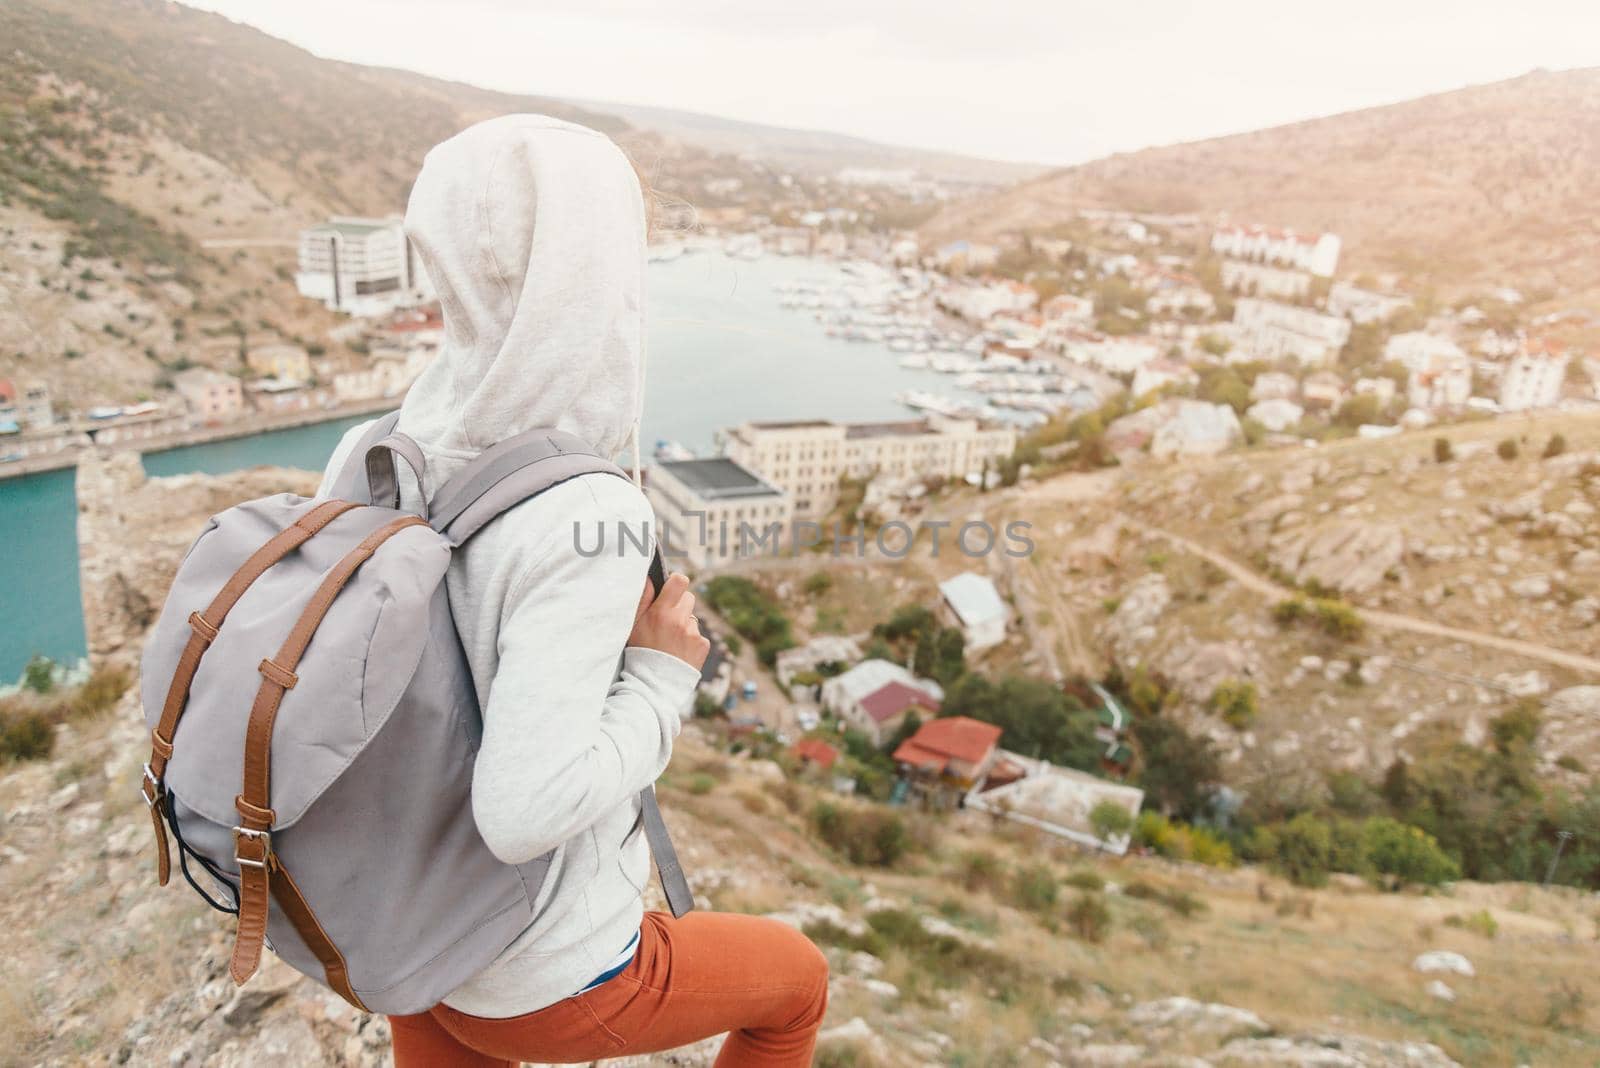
325, 115, 827, 1068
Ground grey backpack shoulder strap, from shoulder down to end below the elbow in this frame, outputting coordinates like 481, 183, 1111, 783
429, 428, 694, 916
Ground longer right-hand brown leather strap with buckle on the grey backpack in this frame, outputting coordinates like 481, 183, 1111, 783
229, 515, 427, 983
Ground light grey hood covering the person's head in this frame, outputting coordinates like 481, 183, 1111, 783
398, 115, 645, 484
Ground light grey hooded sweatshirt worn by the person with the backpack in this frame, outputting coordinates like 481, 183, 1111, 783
322, 115, 699, 1017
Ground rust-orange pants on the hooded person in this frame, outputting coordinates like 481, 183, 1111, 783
389, 913, 827, 1068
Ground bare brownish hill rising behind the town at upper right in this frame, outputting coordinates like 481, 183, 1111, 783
926, 69, 1600, 305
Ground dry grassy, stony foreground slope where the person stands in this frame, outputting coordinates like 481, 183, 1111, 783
0, 460, 1600, 1068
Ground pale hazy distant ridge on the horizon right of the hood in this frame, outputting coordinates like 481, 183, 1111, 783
579, 101, 1046, 185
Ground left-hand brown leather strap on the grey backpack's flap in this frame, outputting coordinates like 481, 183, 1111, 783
139, 500, 360, 886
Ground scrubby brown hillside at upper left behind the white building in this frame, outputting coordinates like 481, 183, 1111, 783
0, 0, 763, 408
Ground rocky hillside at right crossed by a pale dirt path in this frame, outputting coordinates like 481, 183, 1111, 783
966, 416, 1600, 788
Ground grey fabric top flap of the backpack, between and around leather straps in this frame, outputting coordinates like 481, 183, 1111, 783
142, 494, 450, 828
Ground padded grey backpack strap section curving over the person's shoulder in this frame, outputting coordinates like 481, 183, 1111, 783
429, 428, 627, 547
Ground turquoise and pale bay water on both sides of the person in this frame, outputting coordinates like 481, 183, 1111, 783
0, 253, 949, 684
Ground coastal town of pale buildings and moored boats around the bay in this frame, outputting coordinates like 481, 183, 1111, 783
0, 181, 1600, 482
